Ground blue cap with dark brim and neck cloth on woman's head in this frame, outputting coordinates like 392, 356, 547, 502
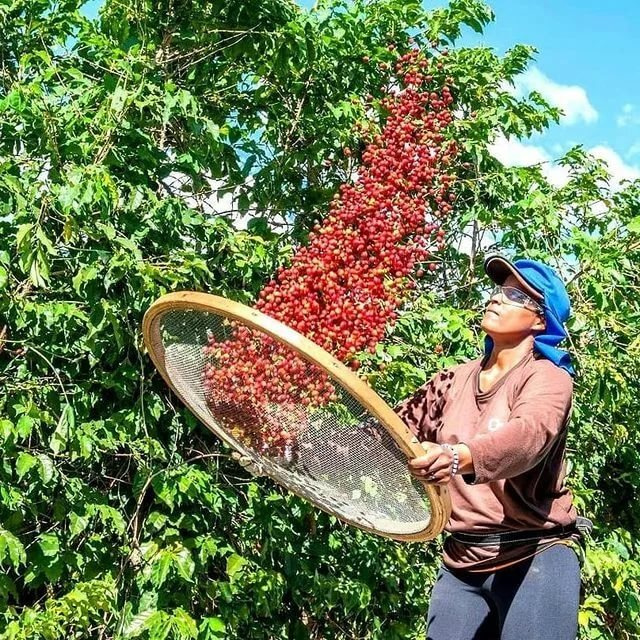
484, 256, 575, 376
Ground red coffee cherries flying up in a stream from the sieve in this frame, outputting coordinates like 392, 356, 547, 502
202, 50, 458, 462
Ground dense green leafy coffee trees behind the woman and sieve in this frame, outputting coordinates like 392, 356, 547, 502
0, 0, 640, 640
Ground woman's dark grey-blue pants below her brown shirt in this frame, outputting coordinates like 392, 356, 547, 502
427, 544, 580, 640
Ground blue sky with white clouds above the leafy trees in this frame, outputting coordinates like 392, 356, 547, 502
85, 0, 640, 182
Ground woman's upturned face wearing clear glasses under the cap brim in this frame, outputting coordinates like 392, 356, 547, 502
481, 275, 545, 342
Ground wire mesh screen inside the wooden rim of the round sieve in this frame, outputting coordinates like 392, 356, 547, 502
154, 310, 431, 535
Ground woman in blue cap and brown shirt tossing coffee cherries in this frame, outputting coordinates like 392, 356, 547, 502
396, 256, 580, 640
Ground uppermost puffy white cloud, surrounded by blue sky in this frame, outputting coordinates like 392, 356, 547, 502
508, 67, 598, 125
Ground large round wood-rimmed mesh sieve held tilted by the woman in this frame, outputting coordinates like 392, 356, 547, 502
143, 292, 451, 540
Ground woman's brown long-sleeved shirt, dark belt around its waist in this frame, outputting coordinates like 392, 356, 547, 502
396, 352, 576, 571
